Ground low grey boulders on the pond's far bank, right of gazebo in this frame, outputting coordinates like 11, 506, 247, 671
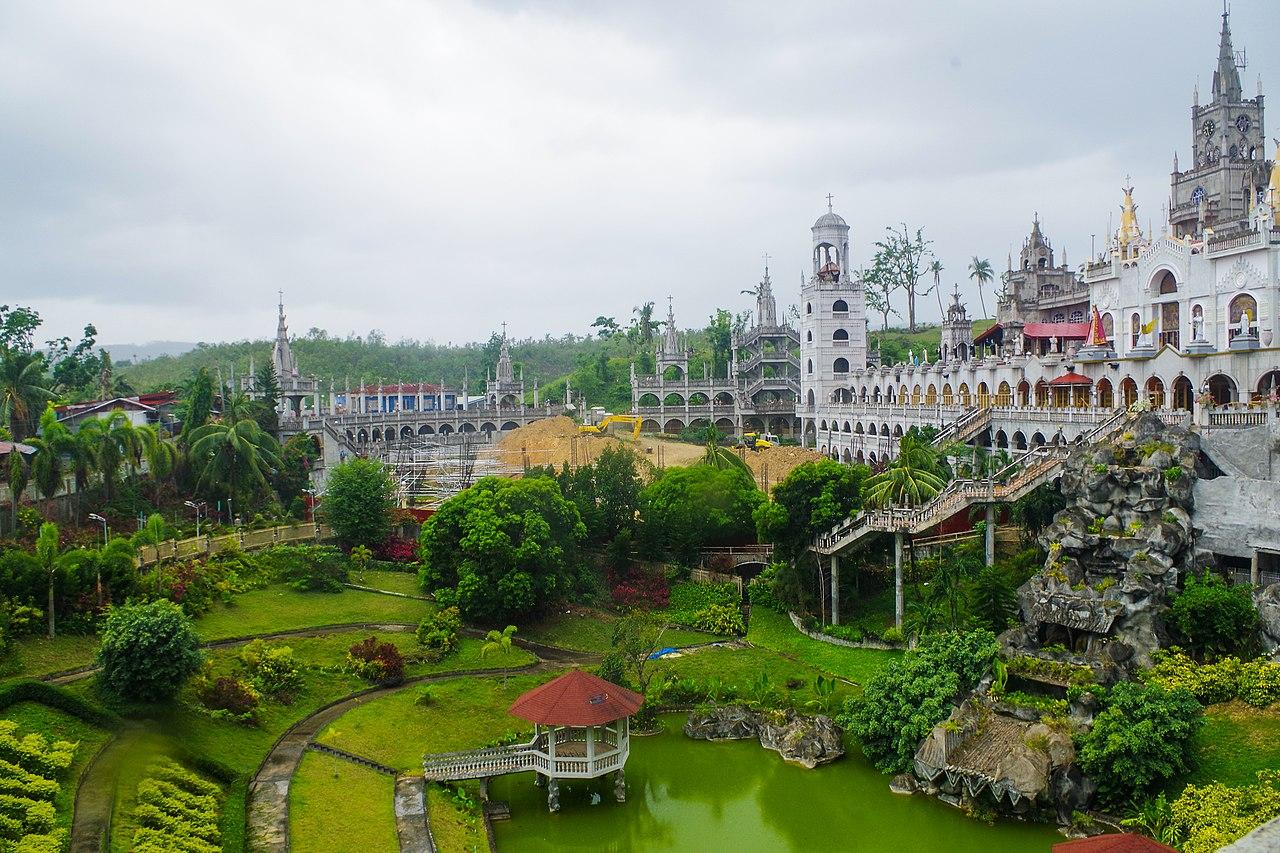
685, 704, 845, 770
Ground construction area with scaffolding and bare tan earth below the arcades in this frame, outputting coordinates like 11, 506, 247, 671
380, 416, 822, 508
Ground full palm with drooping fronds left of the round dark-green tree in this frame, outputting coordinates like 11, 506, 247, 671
189, 410, 280, 506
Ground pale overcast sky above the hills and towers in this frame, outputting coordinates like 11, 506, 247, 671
0, 0, 1280, 342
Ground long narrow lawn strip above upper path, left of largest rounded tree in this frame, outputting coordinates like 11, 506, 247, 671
196, 584, 435, 640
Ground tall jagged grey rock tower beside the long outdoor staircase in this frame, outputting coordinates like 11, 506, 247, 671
1001, 414, 1199, 681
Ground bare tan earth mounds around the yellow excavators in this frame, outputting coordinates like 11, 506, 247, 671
493, 418, 822, 489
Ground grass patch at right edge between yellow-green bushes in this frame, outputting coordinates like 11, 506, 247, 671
1179, 702, 1280, 789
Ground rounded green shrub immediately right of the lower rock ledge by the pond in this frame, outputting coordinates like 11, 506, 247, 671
1076, 681, 1203, 806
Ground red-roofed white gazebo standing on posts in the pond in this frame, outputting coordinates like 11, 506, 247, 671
511, 670, 644, 812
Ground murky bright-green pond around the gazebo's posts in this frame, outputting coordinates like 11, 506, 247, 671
492, 715, 1062, 853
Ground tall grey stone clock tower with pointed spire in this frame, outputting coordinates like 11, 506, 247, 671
1169, 9, 1270, 237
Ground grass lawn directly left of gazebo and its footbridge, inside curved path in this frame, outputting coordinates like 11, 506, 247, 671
316, 674, 554, 772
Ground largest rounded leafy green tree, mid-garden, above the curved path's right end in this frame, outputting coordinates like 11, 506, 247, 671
419, 476, 586, 625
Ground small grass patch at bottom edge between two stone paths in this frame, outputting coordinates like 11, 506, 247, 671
289, 751, 399, 853
